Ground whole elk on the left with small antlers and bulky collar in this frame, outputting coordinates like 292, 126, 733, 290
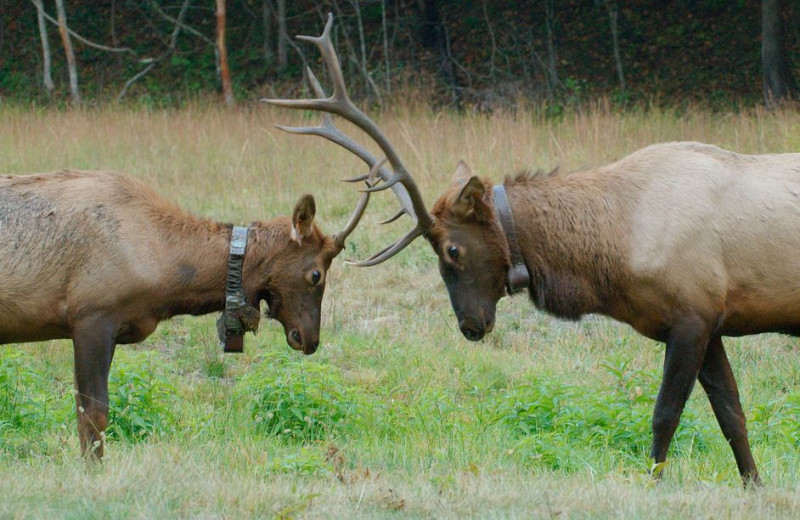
0, 164, 371, 459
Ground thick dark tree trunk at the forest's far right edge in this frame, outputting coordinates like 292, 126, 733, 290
761, 0, 797, 108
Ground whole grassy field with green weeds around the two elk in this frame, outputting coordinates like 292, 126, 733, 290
0, 100, 800, 519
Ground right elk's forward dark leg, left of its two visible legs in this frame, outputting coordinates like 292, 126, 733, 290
650, 317, 709, 476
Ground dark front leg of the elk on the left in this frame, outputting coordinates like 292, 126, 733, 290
72, 320, 115, 459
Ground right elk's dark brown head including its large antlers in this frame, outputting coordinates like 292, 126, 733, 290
265, 14, 511, 341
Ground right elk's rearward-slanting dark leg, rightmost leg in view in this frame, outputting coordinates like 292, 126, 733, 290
698, 336, 761, 486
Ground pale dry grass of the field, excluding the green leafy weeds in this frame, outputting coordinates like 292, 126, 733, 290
0, 103, 800, 519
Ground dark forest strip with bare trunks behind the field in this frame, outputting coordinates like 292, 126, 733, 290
0, 0, 800, 109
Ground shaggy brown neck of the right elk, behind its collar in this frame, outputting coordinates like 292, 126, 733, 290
505, 171, 627, 319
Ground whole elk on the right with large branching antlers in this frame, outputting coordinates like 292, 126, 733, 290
269, 15, 800, 485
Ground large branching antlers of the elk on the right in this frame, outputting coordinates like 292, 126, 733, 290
264, 13, 433, 267
